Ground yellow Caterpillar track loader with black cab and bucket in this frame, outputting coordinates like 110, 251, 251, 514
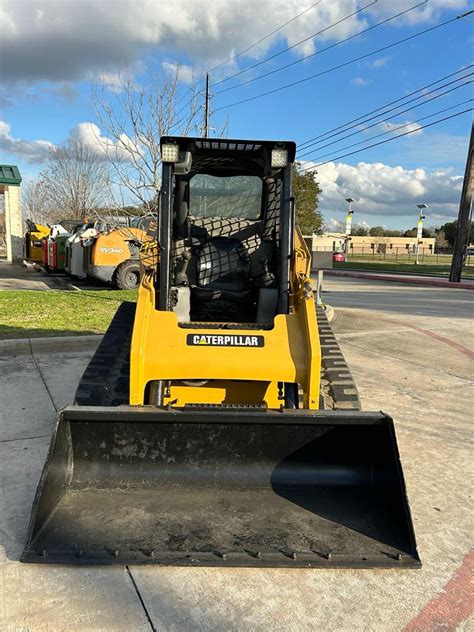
22, 137, 420, 568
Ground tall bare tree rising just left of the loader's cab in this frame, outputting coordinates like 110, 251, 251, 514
94, 66, 201, 212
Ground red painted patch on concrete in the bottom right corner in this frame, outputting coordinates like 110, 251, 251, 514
402, 550, 474, 632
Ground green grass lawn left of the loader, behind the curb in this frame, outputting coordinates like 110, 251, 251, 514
0, 290, 138, 340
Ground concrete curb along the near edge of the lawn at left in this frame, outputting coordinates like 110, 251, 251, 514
0, 334, 103, 357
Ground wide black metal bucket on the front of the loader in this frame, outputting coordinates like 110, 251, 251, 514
22, 406, 420, 568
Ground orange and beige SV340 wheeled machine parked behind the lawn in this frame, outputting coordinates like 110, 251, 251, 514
83, 217, 150, 290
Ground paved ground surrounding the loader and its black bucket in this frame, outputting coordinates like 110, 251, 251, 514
0, 278, 474, 632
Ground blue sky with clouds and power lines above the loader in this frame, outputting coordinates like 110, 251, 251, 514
0, 0, 474, 229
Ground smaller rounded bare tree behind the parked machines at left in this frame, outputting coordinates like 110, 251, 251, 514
40, 138, 111, 220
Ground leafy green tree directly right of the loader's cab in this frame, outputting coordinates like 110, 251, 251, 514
293, 163, 324, 235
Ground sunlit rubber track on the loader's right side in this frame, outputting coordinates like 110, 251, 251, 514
316, 305, 361, 410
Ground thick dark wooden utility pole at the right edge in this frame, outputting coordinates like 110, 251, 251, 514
449, 125, 474, 283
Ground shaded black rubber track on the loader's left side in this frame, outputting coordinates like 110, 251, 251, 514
74, 302, 136, 406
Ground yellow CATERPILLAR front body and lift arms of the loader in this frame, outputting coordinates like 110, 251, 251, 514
130, 230, 321, 409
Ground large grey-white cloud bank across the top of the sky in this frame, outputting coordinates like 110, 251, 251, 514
0, 0, 467, 89
